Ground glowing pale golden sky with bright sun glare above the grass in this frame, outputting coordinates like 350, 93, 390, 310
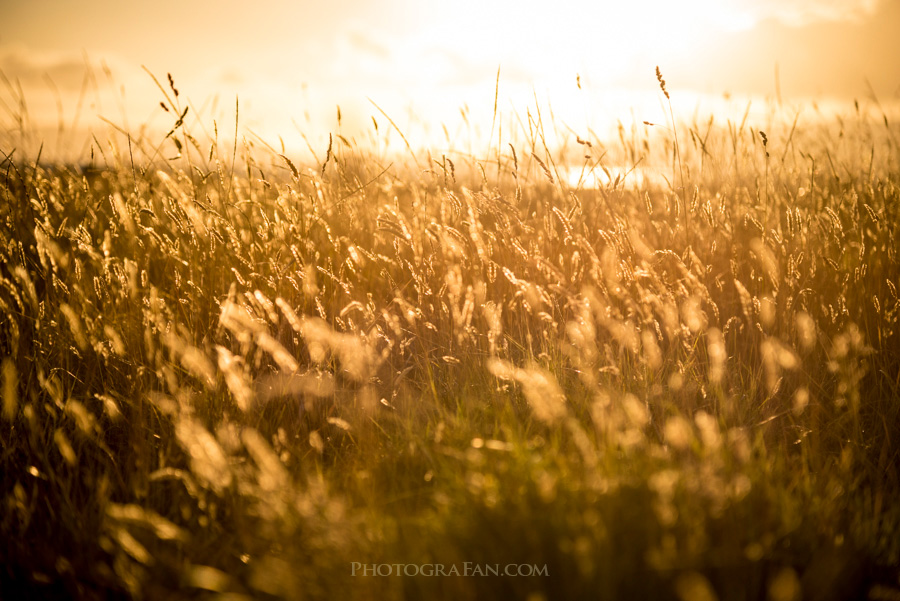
0, 0, 900, 161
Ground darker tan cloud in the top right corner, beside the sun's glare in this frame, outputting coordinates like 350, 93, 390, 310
666, 0, 900, 99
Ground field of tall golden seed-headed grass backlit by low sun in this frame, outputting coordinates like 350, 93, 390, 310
0, 76, 900, 601
